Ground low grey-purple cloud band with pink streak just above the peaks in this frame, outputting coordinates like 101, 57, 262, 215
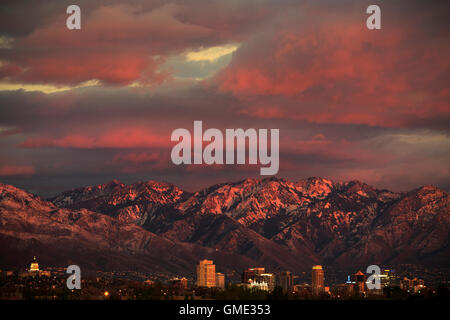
0, 86, 450, 194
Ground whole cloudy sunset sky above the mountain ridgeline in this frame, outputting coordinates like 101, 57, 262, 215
0, 0, 450, 196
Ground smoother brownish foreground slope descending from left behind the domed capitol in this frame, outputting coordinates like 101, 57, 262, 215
0, 184, 274, 276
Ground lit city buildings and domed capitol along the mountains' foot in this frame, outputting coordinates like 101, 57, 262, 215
0, 257, 440, 300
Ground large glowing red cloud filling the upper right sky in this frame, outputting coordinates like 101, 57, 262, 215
215, 3, 450, 127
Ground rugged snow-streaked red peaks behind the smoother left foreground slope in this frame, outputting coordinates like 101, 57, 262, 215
50, 178, 450, 268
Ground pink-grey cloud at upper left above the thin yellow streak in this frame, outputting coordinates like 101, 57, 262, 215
0, 4, 213, 85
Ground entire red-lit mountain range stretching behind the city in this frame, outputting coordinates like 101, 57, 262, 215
0, 178, 450, 276
